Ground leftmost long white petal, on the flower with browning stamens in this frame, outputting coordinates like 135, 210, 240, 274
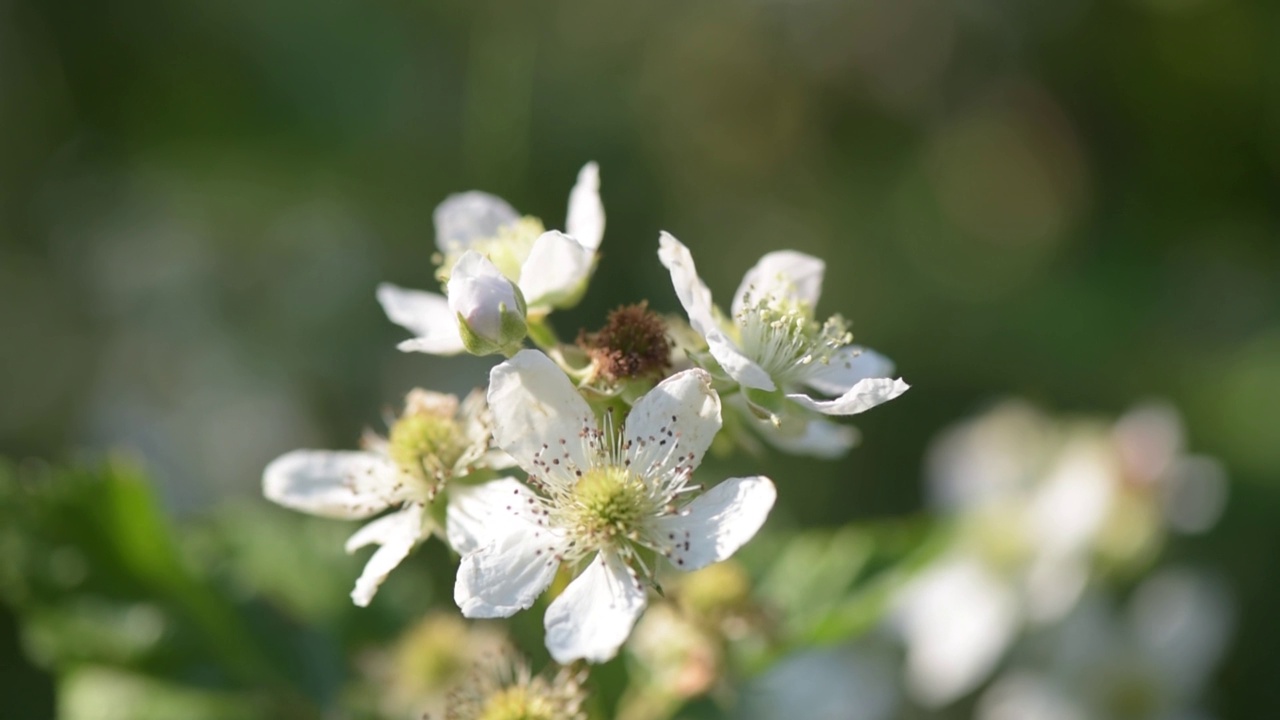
262, 450, 399, 520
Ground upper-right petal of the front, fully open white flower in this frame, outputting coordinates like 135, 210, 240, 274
625, 369, 721, 475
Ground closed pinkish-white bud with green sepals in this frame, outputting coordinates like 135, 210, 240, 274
448, 250, 529, 355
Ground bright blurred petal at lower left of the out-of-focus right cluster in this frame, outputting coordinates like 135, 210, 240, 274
897, 556, 1019, 707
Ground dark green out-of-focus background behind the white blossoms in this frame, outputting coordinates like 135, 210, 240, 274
0, 0, 1280, 717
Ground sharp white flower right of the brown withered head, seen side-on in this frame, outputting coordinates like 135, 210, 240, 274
658, 233, 908, 425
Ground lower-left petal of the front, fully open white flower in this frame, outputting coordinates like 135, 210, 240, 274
453, 486, 564, 618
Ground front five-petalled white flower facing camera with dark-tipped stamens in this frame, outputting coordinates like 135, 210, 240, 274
454, 350, 776, 664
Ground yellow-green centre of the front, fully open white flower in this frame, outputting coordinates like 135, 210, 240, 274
572, 466, 654, 544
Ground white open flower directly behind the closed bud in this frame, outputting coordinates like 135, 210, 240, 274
378, 163, 604, 355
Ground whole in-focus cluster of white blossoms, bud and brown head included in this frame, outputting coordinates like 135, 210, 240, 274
264, 163, 908, 671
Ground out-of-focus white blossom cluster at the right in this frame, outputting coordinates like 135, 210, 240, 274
895, 401, 1225, 706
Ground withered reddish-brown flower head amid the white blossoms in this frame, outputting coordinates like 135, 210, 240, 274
577, 301, 671, 382
